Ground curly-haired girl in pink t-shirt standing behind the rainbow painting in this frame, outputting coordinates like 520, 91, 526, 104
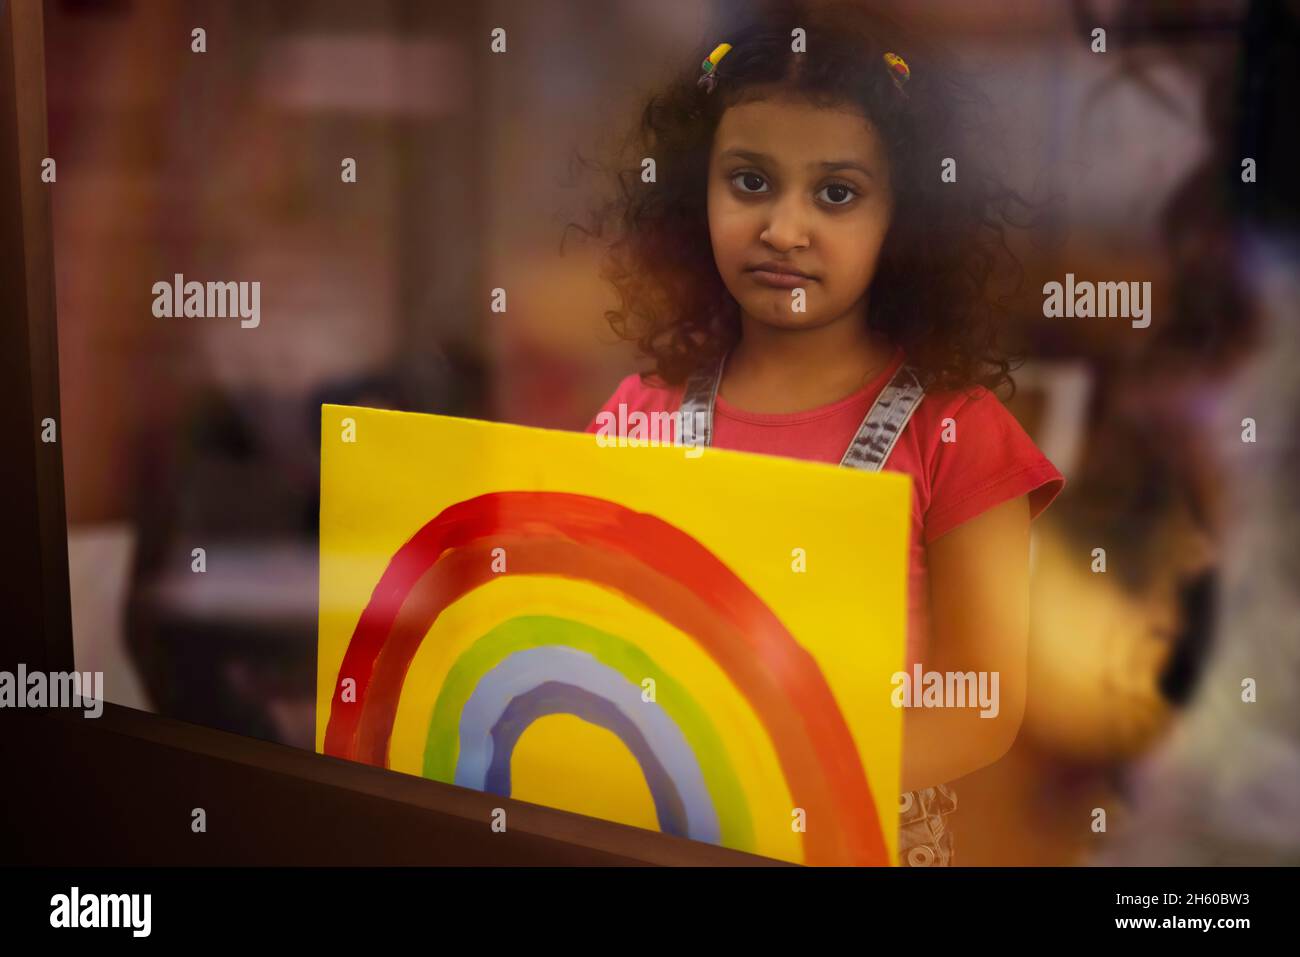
589, 4, 1065, 865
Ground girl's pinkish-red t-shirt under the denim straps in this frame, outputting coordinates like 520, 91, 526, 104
586, 348, 1065, 668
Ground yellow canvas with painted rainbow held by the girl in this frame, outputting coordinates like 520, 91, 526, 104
316, 406, 911, 865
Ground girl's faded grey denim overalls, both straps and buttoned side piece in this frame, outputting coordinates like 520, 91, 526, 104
680, 356, 957, 867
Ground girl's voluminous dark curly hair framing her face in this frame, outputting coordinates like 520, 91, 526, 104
562, 0, 1031, 393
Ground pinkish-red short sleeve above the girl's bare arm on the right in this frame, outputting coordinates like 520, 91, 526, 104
924, 389, 1065, 545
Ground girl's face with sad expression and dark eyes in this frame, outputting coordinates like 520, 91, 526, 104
709, 95, 893, 329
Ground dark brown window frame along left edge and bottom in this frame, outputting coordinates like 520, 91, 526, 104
0, 0, 777, 865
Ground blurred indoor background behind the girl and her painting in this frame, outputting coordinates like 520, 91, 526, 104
46, 0, 1300, 865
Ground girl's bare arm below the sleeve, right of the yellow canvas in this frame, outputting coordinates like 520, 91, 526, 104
902, 495, 1030, 791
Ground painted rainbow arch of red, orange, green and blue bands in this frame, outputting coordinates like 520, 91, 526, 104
324, 492, 889, 865
